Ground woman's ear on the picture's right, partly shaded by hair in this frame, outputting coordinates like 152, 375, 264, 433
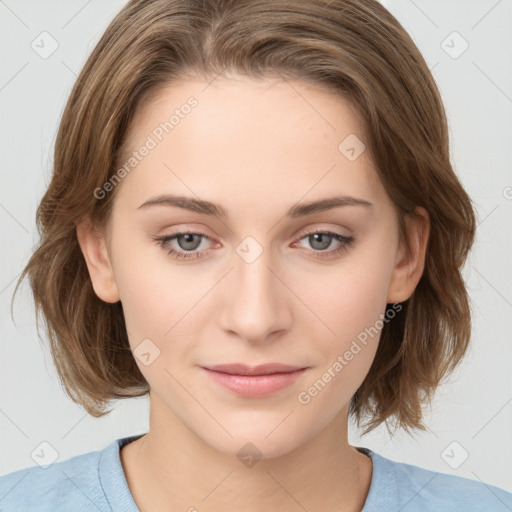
387, 207, 430, 303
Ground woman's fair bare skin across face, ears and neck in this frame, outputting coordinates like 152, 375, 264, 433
77, 76, 429, 512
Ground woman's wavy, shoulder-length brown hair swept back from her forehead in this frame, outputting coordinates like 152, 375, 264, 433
14, 0, 476, 434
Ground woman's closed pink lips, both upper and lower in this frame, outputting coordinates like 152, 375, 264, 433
201, 363, 307, 398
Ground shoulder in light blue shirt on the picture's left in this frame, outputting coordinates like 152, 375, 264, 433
0, 442, 110, 512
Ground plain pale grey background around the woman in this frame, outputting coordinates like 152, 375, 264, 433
0, 0, 512, 491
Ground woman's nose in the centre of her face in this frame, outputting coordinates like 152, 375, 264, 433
220, 243, 293, 344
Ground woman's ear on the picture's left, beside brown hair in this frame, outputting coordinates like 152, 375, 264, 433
76, 220, 120, 303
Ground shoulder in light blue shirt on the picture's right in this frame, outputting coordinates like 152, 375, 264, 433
364, 450, 512, 512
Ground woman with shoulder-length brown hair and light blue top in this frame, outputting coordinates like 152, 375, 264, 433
0, 0, 512, 512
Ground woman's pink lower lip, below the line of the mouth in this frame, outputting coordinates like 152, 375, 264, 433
202, 368, 307, 398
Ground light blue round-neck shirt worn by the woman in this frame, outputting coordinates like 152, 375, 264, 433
0, 434, 512, 512
